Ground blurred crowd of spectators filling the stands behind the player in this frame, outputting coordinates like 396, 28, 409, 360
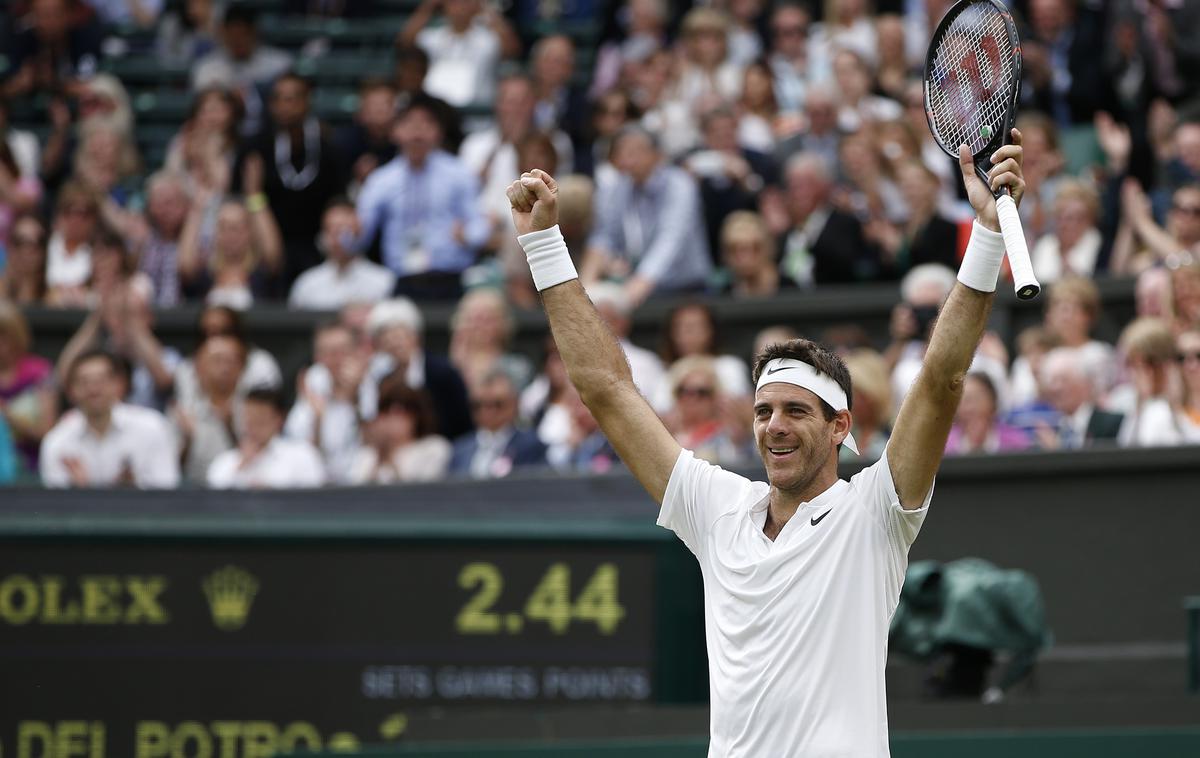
0, 0, 1200, 487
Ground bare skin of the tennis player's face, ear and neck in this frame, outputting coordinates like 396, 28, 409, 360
754, 381, 852, 515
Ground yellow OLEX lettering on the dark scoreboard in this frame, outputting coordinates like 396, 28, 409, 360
0, 573, 170, 626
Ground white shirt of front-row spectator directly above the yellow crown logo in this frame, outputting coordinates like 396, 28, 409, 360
209, 437, 325, 489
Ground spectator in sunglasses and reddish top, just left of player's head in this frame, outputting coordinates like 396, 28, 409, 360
667, 355, 749, 464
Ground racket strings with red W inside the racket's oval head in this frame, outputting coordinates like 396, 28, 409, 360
926, 4, 1015, 154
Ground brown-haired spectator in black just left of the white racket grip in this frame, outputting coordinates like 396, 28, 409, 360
868, 160, 959, 278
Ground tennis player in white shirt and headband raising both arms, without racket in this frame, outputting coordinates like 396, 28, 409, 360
508, 130, 1025, 758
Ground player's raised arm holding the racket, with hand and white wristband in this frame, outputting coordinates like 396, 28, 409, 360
888, 130, 1025, 509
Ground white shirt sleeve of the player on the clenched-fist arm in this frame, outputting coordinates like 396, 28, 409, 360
658, 450, 752, 558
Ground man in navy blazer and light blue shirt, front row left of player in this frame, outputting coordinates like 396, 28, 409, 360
450, 369, 546, 479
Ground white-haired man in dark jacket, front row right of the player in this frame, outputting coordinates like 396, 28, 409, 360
1034, 348, 1122, 450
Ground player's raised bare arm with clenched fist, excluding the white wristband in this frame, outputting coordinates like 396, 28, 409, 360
508, 170, 680, 504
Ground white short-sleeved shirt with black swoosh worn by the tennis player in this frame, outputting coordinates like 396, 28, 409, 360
658, 450, 932, 758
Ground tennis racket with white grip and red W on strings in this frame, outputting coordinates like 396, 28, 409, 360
925, 0, 1042, 300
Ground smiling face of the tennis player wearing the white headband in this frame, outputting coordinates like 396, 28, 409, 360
754, 381, 836, 492
